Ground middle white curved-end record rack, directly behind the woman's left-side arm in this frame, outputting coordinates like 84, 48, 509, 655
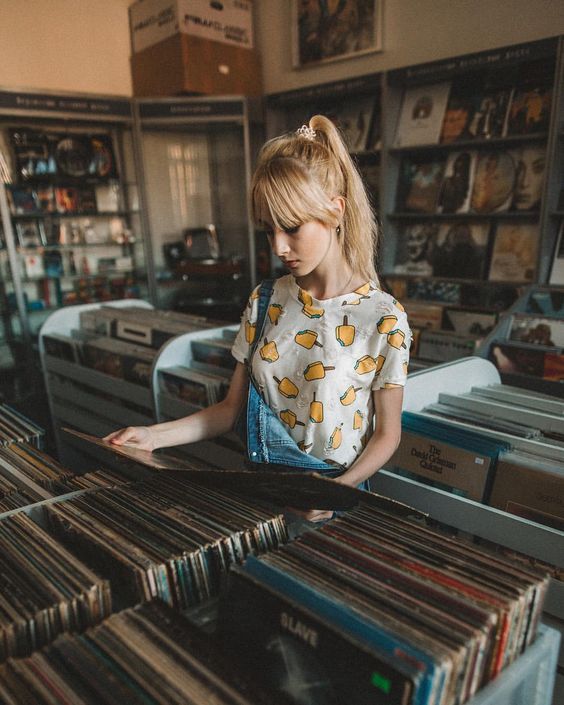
151, 325, 244, 470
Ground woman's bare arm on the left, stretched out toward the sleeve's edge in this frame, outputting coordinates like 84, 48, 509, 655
104, 362, 248, 451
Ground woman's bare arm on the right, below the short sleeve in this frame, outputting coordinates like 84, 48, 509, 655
337, 387, 403, 487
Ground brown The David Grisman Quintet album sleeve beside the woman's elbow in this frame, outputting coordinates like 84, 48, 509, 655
385, 431, 492, 502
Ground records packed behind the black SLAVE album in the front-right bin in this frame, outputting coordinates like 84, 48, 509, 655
218, 507, 548, 705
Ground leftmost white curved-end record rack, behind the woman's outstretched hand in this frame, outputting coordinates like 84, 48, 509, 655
39, 299, 154, 471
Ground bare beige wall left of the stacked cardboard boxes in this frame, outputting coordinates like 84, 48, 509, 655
0, 0, 132, 95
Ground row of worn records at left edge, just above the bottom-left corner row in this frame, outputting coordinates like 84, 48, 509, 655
0, 513, 111, 656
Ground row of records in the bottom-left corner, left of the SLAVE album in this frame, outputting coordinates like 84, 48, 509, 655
0, 602, 267, 705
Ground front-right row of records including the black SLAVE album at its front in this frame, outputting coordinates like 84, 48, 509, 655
218, 506, 548, 704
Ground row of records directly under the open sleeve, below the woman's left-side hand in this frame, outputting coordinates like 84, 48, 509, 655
46, 477, 287, 608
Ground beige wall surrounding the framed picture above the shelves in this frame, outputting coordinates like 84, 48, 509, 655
255, 0, 564, 93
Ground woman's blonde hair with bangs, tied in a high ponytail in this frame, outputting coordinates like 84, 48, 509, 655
250, 115, 378, 281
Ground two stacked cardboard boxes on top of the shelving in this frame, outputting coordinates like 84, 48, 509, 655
129, 0, 262, 97
